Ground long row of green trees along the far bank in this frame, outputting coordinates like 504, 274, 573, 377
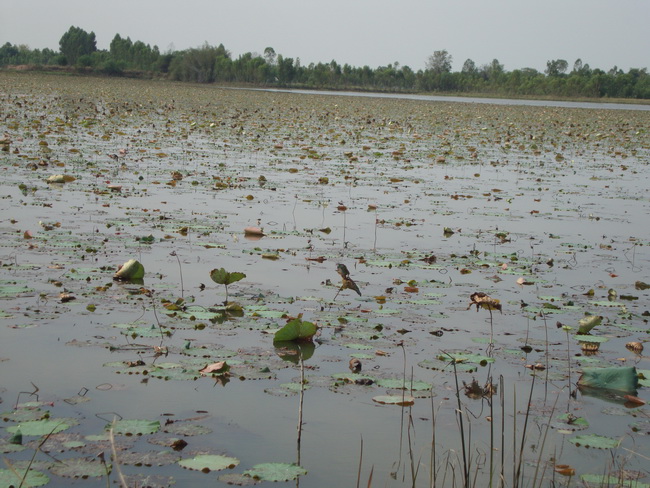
0, 27, 650, 99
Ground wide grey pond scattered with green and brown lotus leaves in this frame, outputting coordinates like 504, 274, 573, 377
0, 73, 650, 487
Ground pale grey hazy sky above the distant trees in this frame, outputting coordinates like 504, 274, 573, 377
5, 0, 650, 71
